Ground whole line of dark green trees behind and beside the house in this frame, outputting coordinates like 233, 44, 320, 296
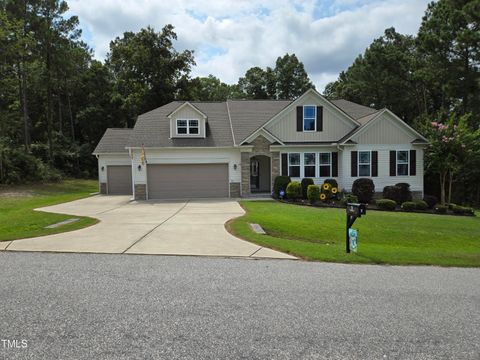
0, 0, 480, 203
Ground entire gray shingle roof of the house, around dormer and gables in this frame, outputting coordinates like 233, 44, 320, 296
94, 99, 378, 154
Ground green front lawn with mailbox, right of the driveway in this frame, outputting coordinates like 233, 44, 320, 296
227, 201, 480, 266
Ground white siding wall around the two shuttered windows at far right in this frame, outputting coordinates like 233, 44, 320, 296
341, 144, 423, 193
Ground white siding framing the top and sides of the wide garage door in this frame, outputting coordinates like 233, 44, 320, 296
132, 148, 241, 184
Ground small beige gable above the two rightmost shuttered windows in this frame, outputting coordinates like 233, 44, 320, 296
351, 111, 418, 144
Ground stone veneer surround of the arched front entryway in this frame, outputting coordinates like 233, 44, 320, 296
241, 135, 280, 196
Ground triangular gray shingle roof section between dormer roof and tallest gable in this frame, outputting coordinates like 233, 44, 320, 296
227, 100, 291, 145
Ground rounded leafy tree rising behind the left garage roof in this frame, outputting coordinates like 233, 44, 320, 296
106, 25, 195, 126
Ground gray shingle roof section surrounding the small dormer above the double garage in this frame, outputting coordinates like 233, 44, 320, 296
127, 101, 233, 147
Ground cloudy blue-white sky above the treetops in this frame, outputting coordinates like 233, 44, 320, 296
68, 0, 429, 91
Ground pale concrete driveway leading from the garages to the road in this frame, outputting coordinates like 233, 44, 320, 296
0, 195, 294, 259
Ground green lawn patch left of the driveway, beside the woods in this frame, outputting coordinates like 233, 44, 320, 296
0, 180, 98, 241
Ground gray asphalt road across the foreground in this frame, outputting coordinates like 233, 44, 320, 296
0, 252, 480, 360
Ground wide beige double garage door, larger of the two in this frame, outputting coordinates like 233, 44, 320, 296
147, 164, 228, 199
